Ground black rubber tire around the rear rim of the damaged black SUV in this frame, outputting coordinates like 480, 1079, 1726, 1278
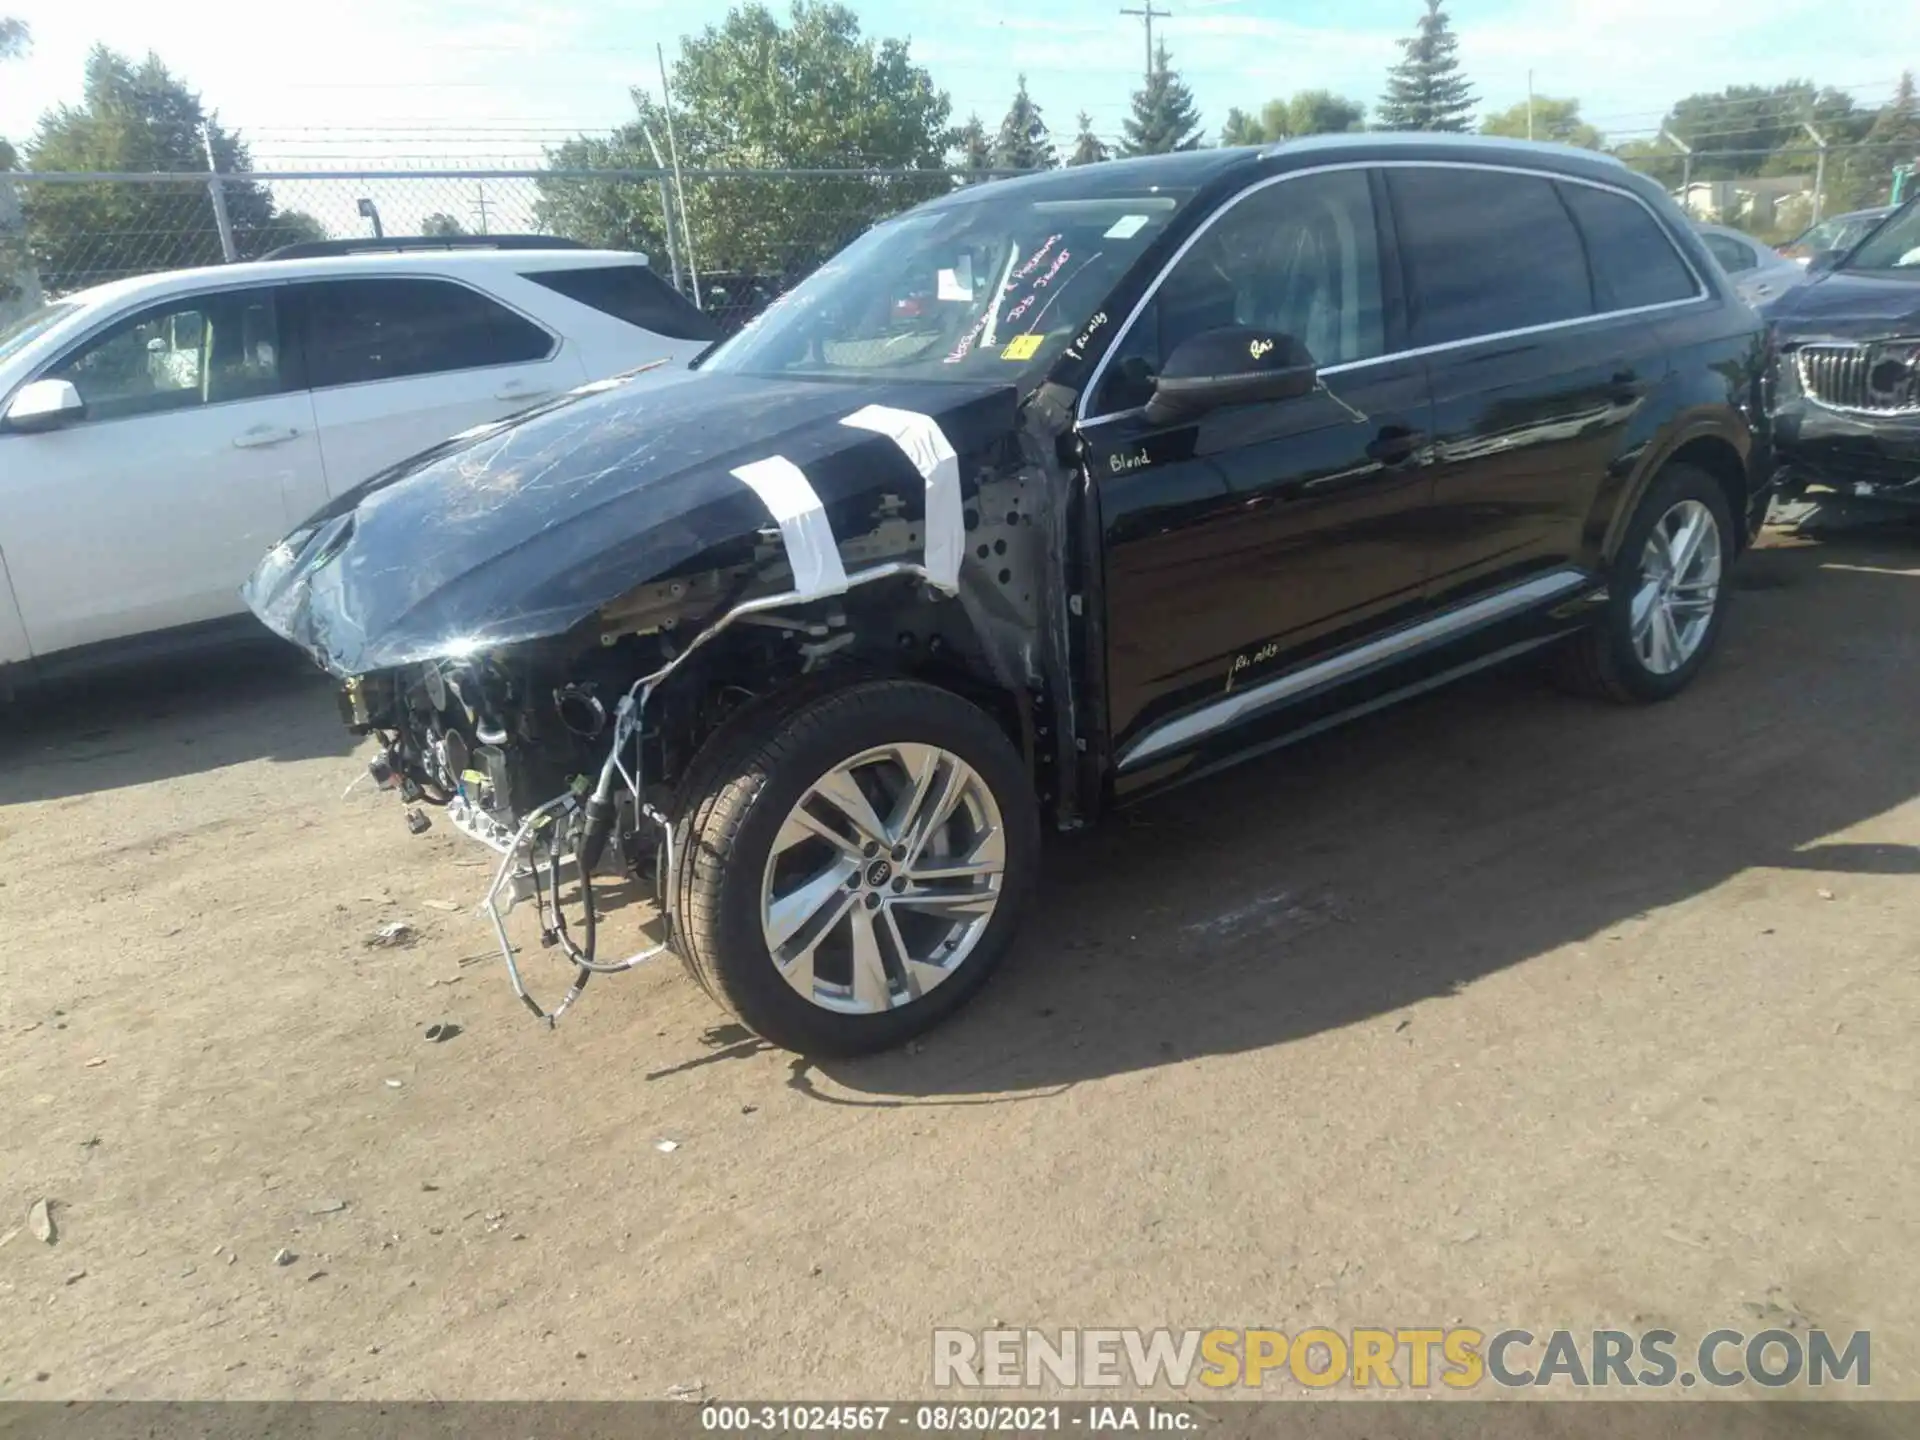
1557, 465, 1736, 705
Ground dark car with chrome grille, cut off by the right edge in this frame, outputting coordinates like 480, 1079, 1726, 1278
1766, 209, 1920, 505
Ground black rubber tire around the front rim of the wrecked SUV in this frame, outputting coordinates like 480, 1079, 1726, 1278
670, 680, 1041, 1056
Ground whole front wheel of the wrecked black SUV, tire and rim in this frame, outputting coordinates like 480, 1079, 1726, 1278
672, 680, 1039, 1054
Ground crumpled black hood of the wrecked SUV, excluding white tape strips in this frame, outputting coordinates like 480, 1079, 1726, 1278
242, 371, 1018, 676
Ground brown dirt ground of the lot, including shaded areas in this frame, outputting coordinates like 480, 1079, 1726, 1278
0, 534, 1920, 1400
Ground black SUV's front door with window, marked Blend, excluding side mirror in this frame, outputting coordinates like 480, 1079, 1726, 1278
1081, 169, 1430, 781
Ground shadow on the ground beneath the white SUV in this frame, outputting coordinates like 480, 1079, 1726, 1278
0, 643, 355, 804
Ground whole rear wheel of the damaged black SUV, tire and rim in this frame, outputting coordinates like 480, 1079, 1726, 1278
1561, 465, 1734, 703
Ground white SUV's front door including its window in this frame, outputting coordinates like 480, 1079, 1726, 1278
0, 286, 326, 655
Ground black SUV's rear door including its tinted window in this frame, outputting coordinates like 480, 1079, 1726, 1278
1388, 163, 1701, 605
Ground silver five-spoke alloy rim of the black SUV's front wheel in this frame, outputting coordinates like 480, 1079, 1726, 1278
760, 745, 1006, 1016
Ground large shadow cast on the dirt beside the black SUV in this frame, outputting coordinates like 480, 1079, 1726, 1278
793, 536, 1920, 1104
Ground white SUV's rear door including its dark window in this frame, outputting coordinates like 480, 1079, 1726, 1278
294, 276, 588, 495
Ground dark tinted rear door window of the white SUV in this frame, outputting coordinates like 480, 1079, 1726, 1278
301, 280, 553, 390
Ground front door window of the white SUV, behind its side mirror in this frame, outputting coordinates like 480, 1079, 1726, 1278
46, 290, 286, 420
